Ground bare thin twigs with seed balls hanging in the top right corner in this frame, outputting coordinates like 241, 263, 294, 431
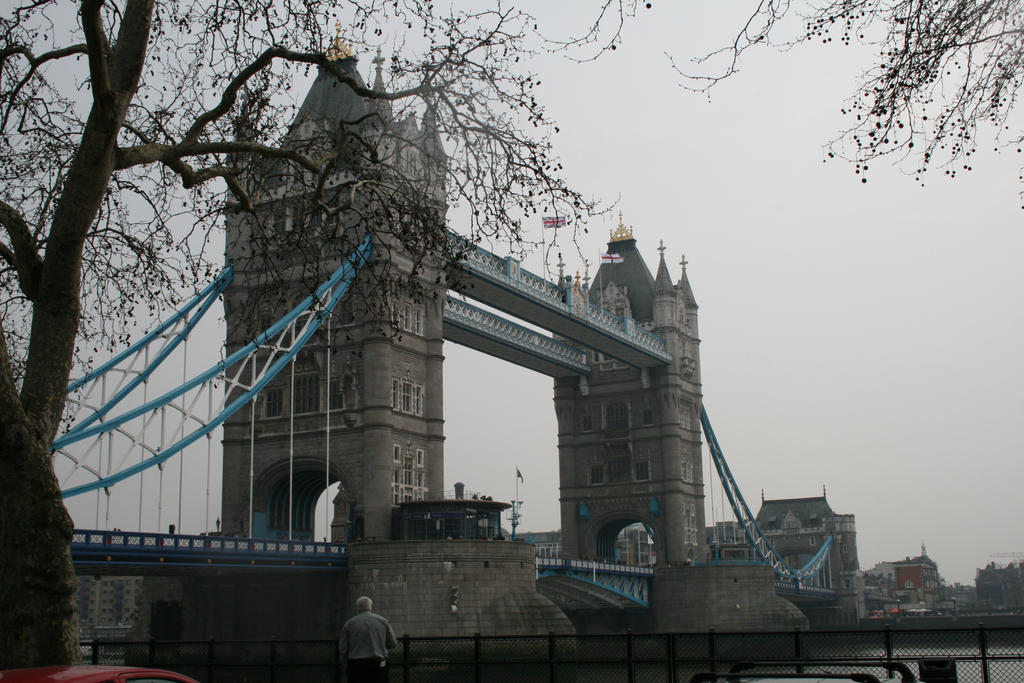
676, 0, 1024, 196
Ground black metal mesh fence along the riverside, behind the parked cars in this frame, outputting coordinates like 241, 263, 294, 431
82, 625, 1024, 683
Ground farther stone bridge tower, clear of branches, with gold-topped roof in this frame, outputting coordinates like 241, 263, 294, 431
555, 216, 706, 565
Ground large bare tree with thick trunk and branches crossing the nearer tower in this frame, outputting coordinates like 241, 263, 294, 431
0, 0, 647, 668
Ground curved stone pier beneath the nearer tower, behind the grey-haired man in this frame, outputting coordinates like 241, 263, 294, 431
345, 541, 572, 636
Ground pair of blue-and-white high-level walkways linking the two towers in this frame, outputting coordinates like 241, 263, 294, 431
444, 236, 672, 377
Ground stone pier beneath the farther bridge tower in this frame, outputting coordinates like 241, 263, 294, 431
650, 566, 807, 632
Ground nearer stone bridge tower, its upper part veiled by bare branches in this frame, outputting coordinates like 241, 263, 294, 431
222, 54, 444, 541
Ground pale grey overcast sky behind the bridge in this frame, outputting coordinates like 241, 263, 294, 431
59, 0, 1024, 583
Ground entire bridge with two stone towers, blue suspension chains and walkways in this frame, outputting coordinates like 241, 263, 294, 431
54, 52, 860, 637
